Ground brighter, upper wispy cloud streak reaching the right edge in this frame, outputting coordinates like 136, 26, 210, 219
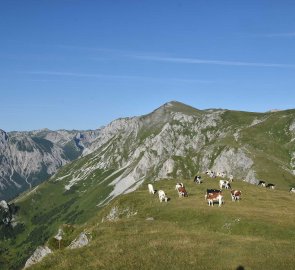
134, 55, 295, 68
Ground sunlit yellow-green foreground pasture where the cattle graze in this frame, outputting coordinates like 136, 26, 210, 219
28, 175, 295, 270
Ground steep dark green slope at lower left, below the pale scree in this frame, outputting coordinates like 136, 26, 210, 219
0, 153, 122, 269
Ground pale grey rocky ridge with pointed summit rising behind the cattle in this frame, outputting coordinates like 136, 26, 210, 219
54, 102, 294, 207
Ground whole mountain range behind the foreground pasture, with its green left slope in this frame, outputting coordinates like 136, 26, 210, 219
0, 101, 295, 269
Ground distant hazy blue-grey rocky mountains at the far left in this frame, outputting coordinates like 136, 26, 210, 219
0, 129, 99, 200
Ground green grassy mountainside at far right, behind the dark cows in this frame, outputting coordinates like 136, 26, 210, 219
240, 110, 295, 188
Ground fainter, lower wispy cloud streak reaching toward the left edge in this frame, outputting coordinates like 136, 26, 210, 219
23, 71, 213, 83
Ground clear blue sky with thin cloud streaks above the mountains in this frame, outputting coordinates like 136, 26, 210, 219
0, 0, 295, 131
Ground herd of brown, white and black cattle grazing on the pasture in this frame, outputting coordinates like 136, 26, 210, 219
148, 171, 295, 207
